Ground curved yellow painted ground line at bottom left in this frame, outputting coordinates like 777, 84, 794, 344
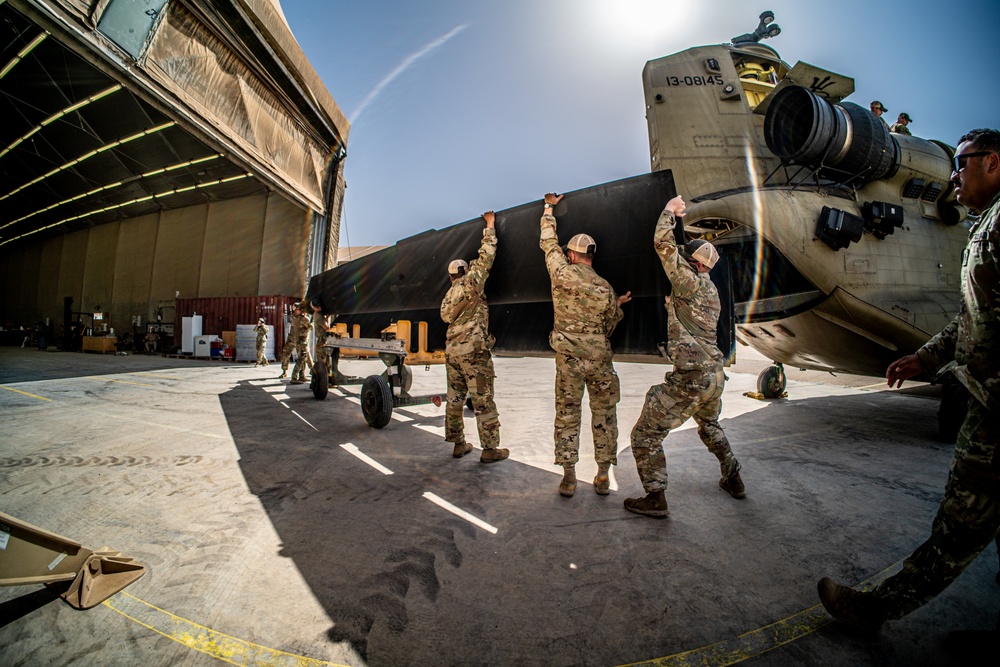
102, 591, 348, 667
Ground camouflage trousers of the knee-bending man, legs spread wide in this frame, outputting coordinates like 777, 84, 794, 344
632, 368, 740, 493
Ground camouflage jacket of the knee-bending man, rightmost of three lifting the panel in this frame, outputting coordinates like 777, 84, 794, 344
653, 210, 722, 371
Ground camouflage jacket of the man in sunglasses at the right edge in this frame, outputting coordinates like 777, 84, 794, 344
917, 192, 1000, 418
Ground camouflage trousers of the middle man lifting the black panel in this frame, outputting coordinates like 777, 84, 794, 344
553, 352, 621, 465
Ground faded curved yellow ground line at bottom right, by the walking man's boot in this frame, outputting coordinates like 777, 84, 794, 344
622, 561, 903, 667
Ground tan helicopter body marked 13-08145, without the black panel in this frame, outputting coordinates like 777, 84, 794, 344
643, 12, 968, 438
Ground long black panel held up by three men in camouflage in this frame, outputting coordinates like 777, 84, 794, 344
307, 170, 734, 359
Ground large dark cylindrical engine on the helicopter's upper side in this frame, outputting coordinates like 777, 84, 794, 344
764, 86, 900, 185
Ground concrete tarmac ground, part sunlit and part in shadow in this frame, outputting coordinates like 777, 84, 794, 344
0, 347, 1000, 667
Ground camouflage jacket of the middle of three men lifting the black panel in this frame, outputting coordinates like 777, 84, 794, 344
538, 213, 623, 360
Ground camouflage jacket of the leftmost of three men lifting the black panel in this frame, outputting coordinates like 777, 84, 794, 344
441, 228, 497, 357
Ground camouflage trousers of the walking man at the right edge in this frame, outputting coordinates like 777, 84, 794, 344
873, 399, 1000, 618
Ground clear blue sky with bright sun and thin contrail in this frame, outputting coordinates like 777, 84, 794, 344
281, 0, 1000, 246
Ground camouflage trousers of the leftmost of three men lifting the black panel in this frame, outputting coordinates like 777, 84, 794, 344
444, 351, 500, 449
